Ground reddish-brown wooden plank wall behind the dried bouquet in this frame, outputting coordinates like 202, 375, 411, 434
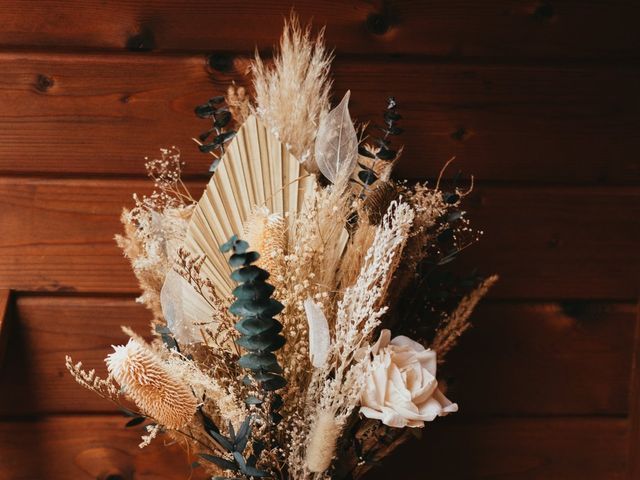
0, 0, 640, 480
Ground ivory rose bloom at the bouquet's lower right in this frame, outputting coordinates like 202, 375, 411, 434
360, 330, 458, 428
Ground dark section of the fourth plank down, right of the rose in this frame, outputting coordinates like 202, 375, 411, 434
441, 302, 636, 415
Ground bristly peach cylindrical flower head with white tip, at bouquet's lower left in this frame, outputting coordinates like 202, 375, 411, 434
105, 338, 197, 430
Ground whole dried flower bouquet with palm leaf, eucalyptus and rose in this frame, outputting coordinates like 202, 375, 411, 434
67, 16, 496, 479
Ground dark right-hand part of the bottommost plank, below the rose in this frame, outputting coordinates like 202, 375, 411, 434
370, 416, 628, 480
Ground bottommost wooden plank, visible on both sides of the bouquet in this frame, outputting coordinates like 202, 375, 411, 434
0, 416, 627, 480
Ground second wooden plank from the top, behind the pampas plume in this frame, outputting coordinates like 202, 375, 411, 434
0, 53, 640, 184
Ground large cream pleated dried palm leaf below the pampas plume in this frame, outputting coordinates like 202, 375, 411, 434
185, 115, 316, 298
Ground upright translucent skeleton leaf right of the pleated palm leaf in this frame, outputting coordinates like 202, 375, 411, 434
315, 91, 358, 184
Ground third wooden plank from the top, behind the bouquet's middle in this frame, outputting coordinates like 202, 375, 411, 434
0, 178, 640, 300
